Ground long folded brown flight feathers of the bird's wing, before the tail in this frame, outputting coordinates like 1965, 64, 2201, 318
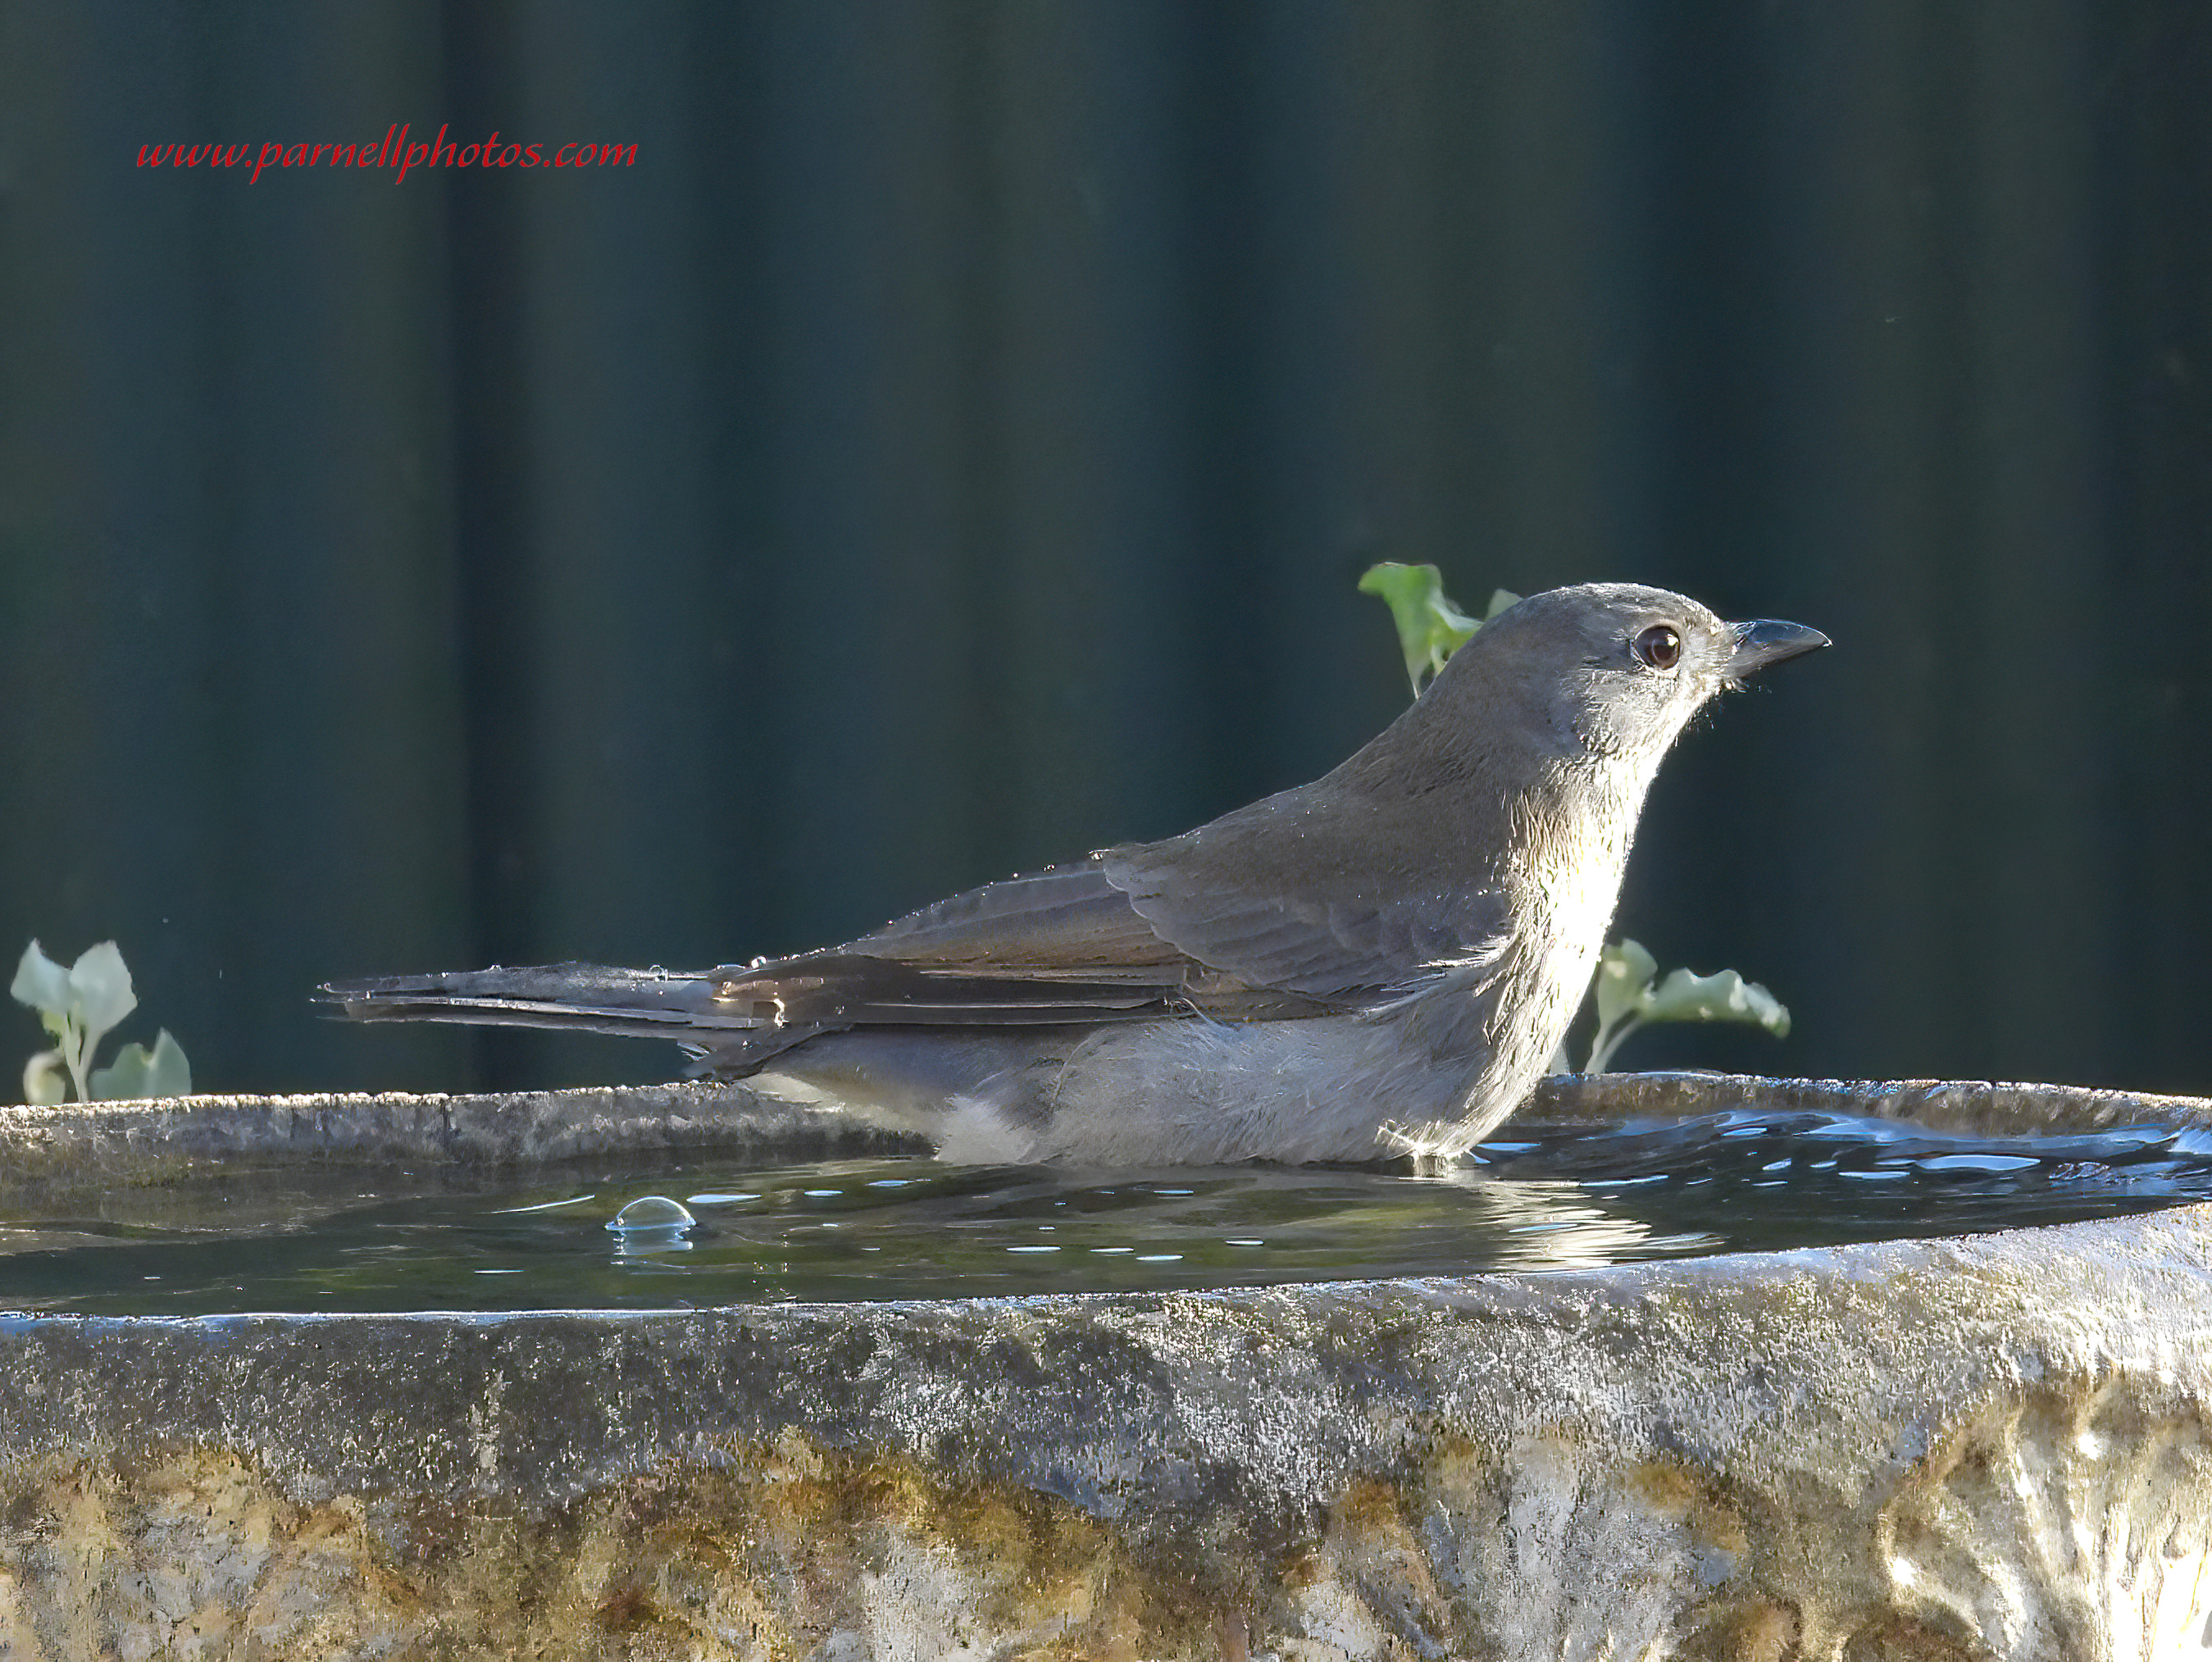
714, 861, 1331, 1029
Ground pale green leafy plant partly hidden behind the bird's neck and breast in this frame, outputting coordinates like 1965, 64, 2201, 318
1360, 560, 1790, 1073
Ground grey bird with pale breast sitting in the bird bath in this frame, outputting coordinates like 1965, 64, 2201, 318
323, 585, 1829, 1164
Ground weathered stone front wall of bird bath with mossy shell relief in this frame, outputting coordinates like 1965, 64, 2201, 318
0, 1082, 2212, 1662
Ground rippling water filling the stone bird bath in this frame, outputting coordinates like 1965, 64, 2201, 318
0, 1111, 2212, 1314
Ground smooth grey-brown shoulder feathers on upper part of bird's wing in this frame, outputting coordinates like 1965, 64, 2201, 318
1097, 817, 1511, 1004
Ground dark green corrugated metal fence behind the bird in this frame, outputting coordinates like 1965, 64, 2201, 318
0, 0, 2212, 1106
